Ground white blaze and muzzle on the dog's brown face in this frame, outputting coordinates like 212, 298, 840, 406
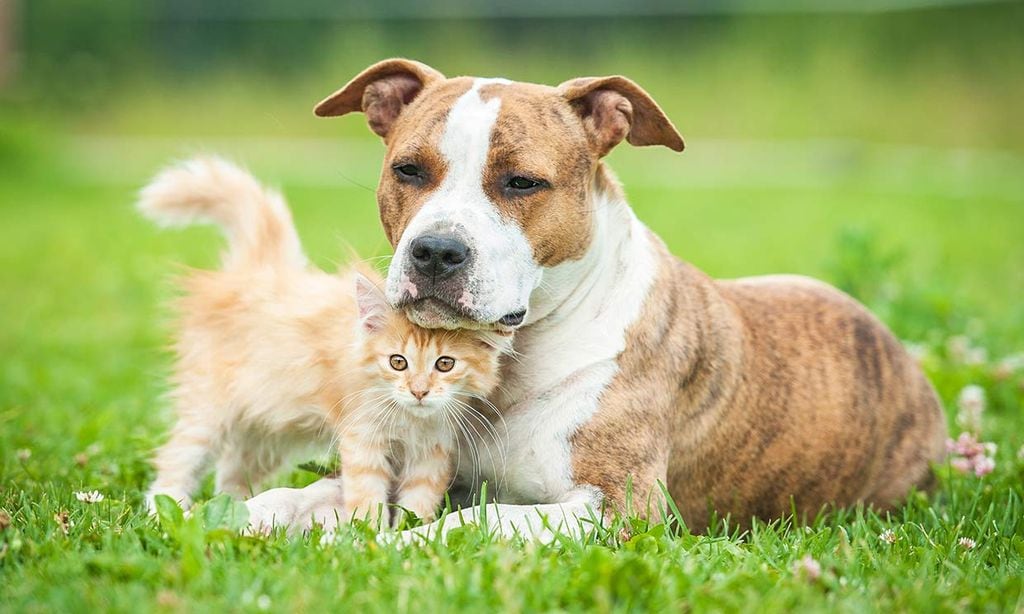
382, 79, 541, 325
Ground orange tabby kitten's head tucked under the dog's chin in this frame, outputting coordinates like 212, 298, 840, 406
355, 275, 511, 418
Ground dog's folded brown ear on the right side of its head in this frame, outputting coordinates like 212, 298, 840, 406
558, 77, 685, 158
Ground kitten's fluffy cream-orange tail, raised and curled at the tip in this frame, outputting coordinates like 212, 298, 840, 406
138, 157, 306, 268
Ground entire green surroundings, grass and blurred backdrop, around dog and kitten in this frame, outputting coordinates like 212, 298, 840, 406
0, 0, 1024, 612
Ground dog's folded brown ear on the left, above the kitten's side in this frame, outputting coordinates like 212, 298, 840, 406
313, 58, 444, 137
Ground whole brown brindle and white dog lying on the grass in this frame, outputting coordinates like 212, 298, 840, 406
248, 59, 946, 538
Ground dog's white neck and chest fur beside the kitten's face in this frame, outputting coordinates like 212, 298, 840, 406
460, 204, 656, 503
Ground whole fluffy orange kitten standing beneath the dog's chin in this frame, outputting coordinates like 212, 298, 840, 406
138, 159, 508, 520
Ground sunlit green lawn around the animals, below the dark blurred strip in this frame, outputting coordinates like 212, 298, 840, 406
0, 7, 1024, 612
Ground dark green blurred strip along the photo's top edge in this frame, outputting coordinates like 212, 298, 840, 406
19, 0, 1024, 94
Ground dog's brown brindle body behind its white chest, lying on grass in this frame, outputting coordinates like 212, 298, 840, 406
571, 180, 946, 531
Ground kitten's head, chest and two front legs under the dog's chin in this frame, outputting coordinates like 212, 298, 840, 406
338, 290, 504, 521
